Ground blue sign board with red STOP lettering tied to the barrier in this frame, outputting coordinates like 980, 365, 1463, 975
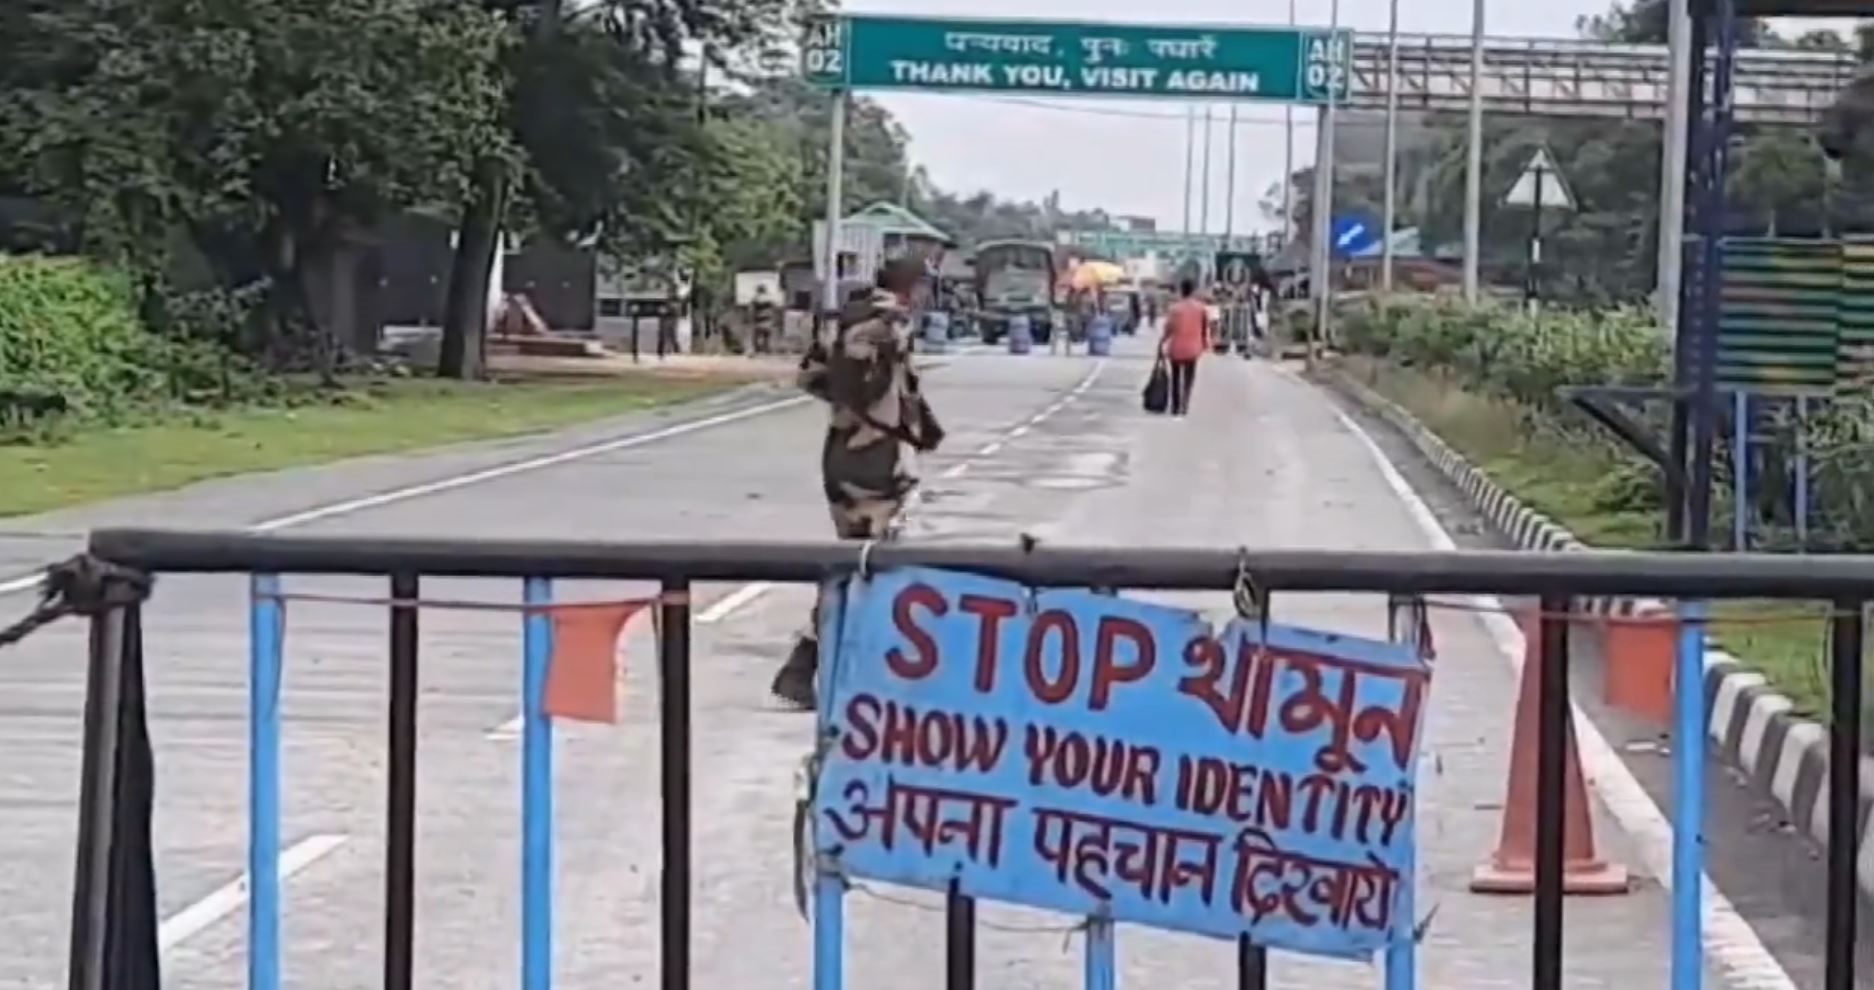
813, 568, 1430, 958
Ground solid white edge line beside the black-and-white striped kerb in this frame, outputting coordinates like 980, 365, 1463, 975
1326, 395, 1795, 990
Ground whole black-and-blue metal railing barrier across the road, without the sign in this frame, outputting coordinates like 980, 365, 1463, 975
45, 531, 1874, 990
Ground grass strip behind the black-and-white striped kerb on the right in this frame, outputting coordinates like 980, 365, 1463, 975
1346, 356, 1874, 722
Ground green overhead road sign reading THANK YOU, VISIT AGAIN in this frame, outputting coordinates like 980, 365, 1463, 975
802, 15, 1353, 103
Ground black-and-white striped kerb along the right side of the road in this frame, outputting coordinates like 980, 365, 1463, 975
1321, 369, 1874, 896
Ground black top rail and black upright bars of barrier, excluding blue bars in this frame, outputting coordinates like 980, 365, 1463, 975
69, 529, 1874, 990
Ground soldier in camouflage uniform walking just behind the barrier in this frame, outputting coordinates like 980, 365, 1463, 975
774, 259, 943, 709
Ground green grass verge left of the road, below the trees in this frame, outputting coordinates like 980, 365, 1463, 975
0, 375, 735, 516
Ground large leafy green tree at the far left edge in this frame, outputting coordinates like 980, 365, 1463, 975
0, 0, 502, 371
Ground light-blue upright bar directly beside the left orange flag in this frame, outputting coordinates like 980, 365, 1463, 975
521, 578, 553, 990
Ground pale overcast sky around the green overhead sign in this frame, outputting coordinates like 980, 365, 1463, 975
847, 0, 1844, 231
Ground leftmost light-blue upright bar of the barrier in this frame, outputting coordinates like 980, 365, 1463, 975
247, 574, 287, 990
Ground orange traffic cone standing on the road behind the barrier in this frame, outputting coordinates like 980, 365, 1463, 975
1471, 611, 1629, 894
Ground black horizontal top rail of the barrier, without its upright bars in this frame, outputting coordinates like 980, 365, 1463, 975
90, 529, 1874, 600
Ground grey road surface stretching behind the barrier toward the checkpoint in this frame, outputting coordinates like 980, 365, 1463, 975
0, 343, 1799, 990
